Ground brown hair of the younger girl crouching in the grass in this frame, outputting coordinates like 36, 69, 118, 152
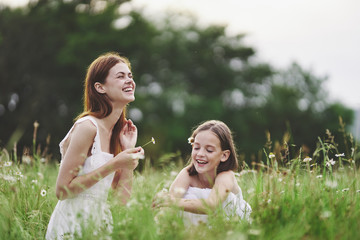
188, 120, 239, 176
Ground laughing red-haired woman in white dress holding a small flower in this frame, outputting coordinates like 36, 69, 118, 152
46, 53, 144, 239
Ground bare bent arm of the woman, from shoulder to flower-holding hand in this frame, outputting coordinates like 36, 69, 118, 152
56, 121, 141, 200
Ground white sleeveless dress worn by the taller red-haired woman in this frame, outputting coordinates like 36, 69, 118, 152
46, 116, 114, 239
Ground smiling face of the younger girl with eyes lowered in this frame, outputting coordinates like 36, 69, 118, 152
191, 130, 229, 176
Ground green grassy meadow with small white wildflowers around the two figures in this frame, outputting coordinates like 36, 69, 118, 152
0, 136, 360, 240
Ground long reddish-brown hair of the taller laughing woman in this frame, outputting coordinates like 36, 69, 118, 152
75, 52, 131, 155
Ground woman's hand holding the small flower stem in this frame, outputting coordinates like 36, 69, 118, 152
113, 147, 144, 170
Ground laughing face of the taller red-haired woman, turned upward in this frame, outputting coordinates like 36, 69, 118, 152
102, 62, 136, 104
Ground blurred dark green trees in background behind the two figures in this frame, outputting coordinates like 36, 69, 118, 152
0, 0, 353, 163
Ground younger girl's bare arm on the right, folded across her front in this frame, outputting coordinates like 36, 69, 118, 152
173, 171, 234, 214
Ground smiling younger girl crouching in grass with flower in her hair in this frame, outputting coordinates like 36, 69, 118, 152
155, 120, 251, 225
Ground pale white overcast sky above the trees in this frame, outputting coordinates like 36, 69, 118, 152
0, 0, 360, 110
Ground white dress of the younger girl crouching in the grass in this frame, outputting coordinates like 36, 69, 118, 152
183, 187, 252, 226
